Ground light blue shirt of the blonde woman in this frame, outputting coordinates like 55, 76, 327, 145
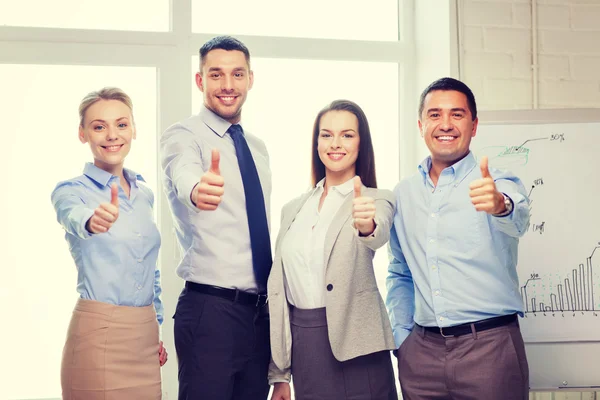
52, 163, 163, 323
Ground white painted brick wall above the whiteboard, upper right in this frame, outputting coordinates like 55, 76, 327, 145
458, 0, 600, 109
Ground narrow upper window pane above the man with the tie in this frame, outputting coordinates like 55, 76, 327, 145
192, 0, 400, 41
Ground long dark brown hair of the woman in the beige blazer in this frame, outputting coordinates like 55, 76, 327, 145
311, 100, 377, 188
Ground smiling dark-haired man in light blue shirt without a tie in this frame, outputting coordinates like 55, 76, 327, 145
387, 78, 529, 400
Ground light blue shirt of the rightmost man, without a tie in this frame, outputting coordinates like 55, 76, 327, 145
386, 153, 529, 347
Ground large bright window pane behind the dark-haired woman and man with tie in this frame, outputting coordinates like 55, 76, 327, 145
192, 57, 399, 295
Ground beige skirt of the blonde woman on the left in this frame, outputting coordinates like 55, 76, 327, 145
61, 299, 161, 400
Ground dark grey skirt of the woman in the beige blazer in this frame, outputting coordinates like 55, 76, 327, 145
290, 307, 398, 400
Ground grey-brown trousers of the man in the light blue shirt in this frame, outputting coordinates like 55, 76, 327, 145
398, 321, 529, 400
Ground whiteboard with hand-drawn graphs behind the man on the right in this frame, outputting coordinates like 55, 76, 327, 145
472, 112, 600, 344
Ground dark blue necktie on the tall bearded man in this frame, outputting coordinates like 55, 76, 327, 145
228, 125, 273, 293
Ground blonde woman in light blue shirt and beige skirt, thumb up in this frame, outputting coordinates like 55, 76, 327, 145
52, 88, 167, 400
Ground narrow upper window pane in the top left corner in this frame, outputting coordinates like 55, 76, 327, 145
0, 0, 170, 32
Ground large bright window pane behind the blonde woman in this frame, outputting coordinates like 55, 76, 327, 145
0, 65, 157, 399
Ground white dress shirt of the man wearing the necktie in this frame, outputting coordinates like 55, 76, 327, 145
160, 107, 271, 293
